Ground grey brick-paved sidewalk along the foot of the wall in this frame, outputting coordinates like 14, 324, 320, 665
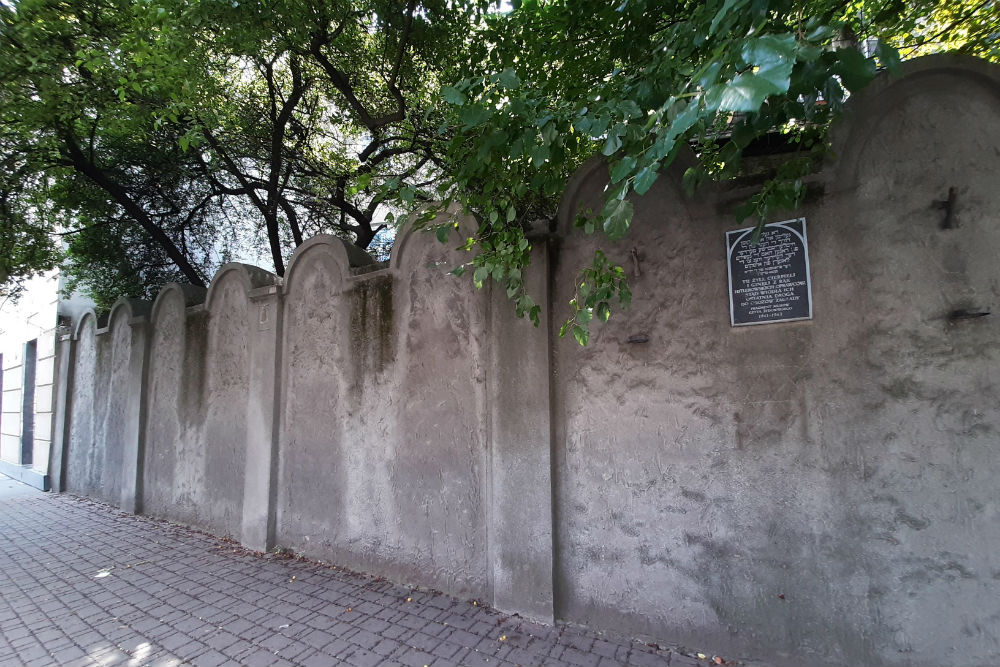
0, 486, 736, 667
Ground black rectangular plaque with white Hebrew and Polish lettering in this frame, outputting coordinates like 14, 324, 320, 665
726, 218, 812, 327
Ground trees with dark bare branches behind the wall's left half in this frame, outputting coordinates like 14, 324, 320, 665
0, 0, 485, 303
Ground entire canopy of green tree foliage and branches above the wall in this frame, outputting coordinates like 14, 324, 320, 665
0, 0, 1000, 322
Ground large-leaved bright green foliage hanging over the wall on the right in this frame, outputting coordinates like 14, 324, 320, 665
434, 0, 1000, 343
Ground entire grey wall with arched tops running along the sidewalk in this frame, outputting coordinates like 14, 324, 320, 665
53, 58, 1000, 665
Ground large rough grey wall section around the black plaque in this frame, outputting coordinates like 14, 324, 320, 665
553, 54, 1000, 664
